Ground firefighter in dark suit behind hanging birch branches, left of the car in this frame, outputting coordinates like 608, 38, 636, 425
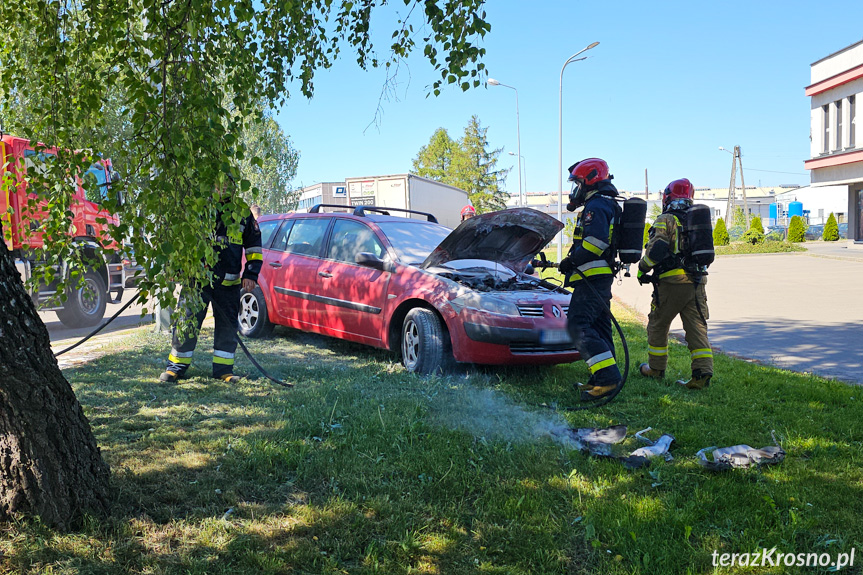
159, 186, 263, 383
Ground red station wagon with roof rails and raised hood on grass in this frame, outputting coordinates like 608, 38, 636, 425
239, 206, 579, 374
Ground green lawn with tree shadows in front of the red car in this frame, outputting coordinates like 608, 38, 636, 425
0, 309, 863, 575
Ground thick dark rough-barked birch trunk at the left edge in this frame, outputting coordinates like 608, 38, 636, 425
0, 230, 110, 530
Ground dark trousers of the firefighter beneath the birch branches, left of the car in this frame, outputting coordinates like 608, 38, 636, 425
167, 285, 240, 378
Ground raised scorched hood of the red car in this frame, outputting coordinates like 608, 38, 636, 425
420, 208, 563, 273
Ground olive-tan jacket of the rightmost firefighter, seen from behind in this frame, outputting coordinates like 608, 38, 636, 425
638, 211, 692, 283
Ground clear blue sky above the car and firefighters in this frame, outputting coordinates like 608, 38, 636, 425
277, 0, 863, 196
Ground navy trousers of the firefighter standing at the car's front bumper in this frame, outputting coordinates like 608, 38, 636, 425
567, 275, 621, 385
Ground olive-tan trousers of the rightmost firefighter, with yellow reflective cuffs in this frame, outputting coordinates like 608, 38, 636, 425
647, 280, 713, 375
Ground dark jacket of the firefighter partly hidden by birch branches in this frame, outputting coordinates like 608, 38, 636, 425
213, 211, 264, 286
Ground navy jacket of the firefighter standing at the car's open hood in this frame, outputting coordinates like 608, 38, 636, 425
567, 180, 621, 285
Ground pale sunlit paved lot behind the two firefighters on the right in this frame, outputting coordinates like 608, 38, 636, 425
612, 242, 863, 384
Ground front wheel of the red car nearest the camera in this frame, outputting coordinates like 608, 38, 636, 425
401, 308, 454, 375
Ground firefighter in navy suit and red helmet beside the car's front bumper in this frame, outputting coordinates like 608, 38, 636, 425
558, 158, 621, 401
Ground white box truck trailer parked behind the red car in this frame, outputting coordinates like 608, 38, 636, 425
345, 174, 470, 228
